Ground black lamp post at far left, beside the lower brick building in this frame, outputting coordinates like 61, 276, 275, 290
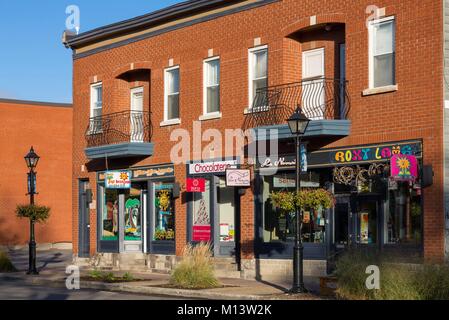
25, 147, 40, 275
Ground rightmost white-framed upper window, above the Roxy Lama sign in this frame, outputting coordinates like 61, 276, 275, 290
369, 17, 396, 88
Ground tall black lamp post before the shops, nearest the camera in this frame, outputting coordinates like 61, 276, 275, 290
287, 106, 310, 293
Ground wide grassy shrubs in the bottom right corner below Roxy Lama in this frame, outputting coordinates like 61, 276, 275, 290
335, 250, 449, 300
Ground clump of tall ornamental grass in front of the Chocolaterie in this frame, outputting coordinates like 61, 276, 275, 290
170, 243, 219, 289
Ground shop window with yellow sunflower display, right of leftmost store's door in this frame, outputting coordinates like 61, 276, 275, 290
153, 182, 175, 241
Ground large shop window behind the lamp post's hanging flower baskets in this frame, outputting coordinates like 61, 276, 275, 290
262, 172, 326, 243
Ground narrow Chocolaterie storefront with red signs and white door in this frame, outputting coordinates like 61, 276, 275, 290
187, 159, 240, 257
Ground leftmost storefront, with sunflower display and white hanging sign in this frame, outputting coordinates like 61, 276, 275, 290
97, 165, 179, 254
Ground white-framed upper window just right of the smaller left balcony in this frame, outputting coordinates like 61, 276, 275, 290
164, 67, 179, 123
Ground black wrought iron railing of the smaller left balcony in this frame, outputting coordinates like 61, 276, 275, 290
86, 111, 152, 148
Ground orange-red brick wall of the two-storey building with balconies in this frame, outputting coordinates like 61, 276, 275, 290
73, 0, 444, 258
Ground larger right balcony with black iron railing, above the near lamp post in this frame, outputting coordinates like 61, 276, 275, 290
244, 78, 351, 139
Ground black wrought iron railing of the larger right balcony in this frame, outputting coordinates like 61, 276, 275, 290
244, 78, 350, 129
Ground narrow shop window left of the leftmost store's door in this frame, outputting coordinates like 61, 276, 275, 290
101, 188, 119, 241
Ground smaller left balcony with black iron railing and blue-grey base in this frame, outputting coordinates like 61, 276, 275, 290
85, 111, 154, 159
